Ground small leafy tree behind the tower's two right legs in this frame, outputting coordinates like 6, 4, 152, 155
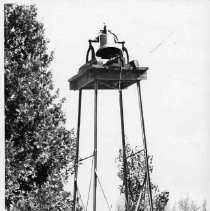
117, 144, 169, 211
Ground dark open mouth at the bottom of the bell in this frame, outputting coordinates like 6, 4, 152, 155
96, 46, 122, 59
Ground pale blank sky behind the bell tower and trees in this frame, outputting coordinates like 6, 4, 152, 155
1, 0, 210, 211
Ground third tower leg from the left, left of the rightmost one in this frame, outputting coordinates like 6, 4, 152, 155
119, 89, 129, 211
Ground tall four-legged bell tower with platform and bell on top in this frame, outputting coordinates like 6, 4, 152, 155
69, 26, 153, 211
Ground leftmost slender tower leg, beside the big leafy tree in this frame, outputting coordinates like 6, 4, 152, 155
73, 89, 82, 211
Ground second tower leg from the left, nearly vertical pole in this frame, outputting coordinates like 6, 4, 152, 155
93, 81, 98, 211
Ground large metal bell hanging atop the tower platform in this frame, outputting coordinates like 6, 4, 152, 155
96, 32, 122, 59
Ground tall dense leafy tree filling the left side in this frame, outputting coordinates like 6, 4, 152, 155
4, 4, 78, 211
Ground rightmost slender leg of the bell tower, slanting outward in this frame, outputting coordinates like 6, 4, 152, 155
137, 81, 153, 211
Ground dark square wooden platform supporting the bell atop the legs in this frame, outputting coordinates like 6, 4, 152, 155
68, 64, 148, 90
